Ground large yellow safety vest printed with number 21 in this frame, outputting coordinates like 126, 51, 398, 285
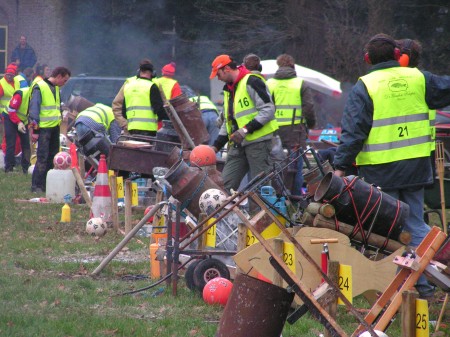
356, 67, 431, 165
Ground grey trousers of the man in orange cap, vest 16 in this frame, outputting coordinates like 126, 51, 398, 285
222, 139, 272, 191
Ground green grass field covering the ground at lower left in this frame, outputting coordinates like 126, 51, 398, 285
0, 171, 446, 337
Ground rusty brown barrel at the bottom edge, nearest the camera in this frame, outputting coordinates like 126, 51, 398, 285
216, 274, 294, 337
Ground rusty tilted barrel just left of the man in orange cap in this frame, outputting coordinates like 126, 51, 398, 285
170, 94, 209, 145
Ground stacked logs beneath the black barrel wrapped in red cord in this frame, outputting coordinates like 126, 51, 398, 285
302, 202, 409, 252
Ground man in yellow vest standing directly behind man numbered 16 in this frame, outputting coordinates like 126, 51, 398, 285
267, 54, 316, 195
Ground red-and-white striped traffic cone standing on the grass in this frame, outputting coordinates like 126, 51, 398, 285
91, 154, 112, 222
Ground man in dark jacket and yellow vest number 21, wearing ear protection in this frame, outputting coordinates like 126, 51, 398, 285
334, 34, 450, 297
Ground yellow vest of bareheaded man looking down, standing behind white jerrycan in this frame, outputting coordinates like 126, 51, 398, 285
35, 81, 61, 128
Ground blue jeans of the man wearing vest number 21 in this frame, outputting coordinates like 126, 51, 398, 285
386, 187, 434, 296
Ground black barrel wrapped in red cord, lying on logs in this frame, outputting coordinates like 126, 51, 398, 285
314, 172, 409, 240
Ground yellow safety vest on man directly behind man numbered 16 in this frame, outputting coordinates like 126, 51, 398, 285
267, 77, 303, 126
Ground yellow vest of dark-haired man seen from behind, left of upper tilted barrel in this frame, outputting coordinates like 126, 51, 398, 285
123, 78, 158, 131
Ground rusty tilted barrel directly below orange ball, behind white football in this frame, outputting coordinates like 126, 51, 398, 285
164, 160, 220, 218
